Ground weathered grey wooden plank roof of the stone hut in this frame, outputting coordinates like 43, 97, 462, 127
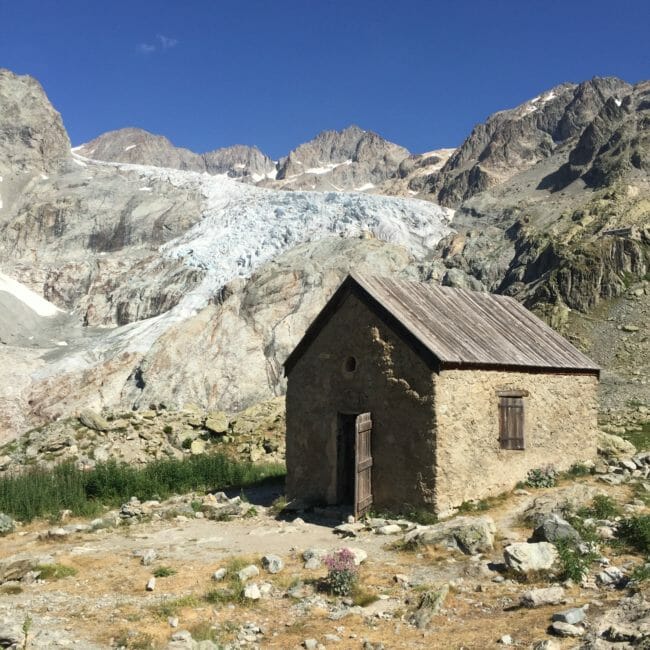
285, 273, 600, 374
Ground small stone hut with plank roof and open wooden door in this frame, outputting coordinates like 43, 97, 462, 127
284, 274, 599, 515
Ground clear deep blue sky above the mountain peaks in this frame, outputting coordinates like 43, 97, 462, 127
0, 0, 650, 157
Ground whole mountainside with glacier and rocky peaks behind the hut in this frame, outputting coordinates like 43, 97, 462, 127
0, 68, 650, 435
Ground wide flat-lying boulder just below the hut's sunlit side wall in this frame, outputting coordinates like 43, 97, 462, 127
404, 517, 496, 555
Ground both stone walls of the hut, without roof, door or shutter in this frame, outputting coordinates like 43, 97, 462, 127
286, 276, 598, 513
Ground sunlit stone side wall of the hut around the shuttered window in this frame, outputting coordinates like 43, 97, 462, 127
434, 370, 598, 512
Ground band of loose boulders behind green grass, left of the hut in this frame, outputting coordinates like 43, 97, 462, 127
0, 397, 285, 473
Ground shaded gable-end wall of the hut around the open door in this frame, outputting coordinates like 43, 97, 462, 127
286, 294, 435, 510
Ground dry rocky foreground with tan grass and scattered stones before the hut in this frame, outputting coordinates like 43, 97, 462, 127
0, 430, 650, 650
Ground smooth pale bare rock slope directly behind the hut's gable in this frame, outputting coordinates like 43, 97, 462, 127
120, 238, 417, 410
